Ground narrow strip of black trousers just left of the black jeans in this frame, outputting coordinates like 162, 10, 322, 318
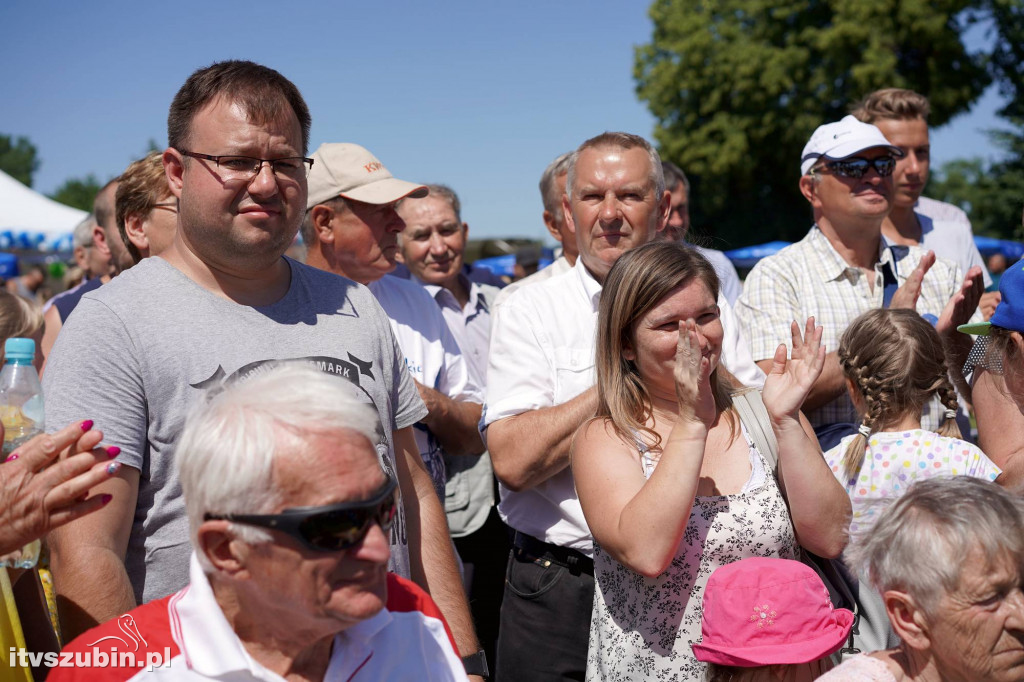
455, 507, 511, 669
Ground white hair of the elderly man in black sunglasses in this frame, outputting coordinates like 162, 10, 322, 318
175, 361, 379, 572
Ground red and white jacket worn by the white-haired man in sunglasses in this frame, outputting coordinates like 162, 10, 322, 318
47, 556, 467, 682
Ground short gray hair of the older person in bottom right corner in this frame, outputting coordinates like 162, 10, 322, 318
846, 476, 1024, 617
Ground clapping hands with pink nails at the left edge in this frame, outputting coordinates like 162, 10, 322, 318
0, 421, 121, 555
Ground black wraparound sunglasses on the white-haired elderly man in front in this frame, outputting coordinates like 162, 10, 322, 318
203, 479, 397, 552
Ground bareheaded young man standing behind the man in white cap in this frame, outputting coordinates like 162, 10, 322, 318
853, 88, 999, 319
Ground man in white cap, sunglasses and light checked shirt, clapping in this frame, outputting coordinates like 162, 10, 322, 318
736, 116, 983, 450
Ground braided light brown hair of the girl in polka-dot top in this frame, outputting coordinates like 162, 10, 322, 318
839, 308, 961, 479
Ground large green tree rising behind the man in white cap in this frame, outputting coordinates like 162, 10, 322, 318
634, 0, 995, 246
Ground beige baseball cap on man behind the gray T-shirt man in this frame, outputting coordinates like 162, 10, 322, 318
306, 142, 427, 210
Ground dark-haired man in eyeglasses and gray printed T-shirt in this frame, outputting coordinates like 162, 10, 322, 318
44, 61, 475, 659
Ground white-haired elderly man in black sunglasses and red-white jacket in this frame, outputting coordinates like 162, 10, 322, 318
50, 363, 466, 682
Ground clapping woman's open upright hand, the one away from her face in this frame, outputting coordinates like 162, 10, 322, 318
761, 317, 825, 420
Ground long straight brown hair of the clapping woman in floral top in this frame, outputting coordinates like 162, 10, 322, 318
596, 242, 736, 447
